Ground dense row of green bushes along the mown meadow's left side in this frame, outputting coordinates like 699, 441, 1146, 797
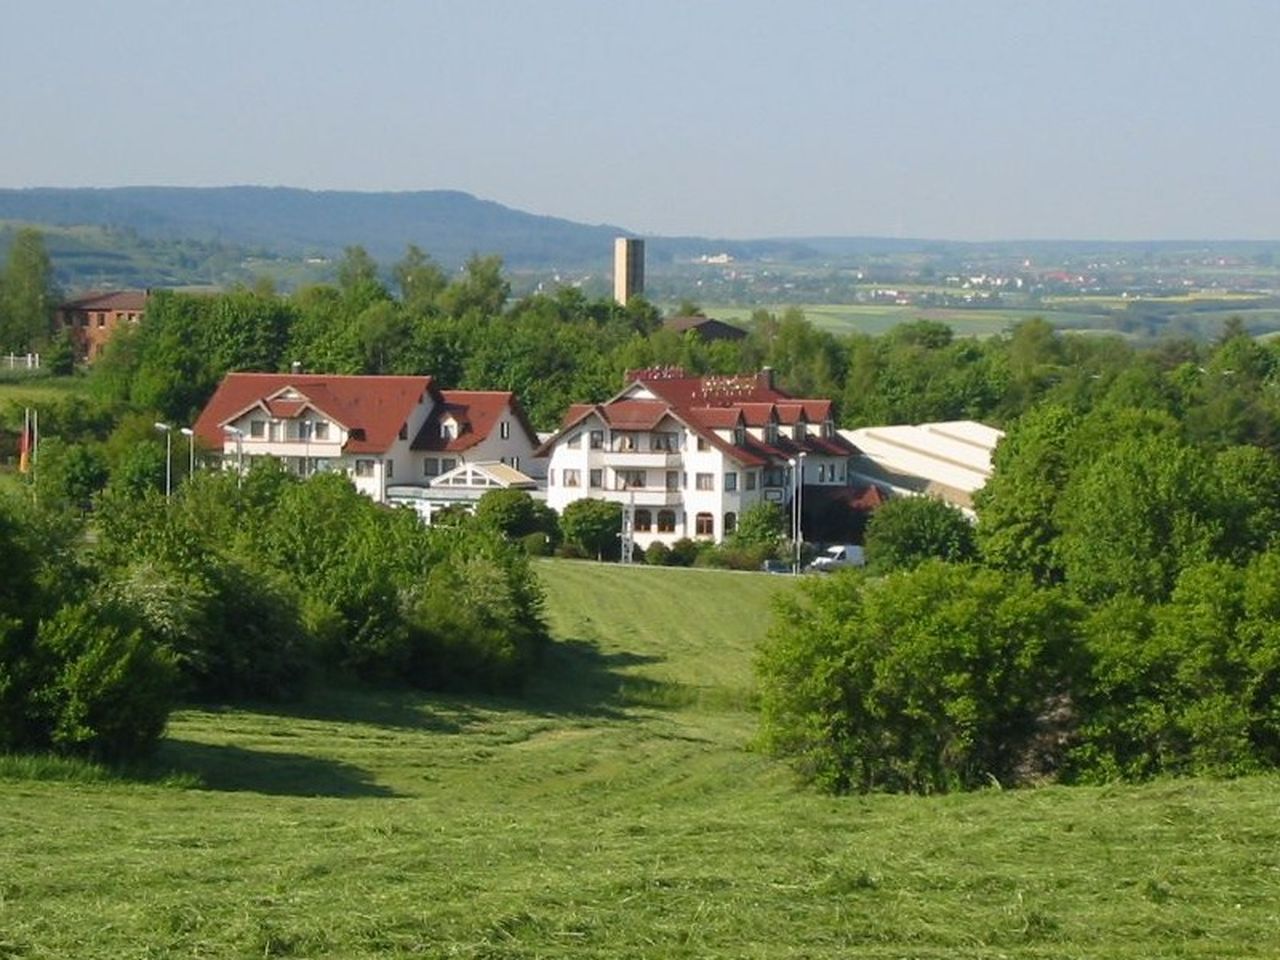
0, 465, 545, 759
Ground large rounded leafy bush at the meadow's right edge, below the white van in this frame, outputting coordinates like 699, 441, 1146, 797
759, 561, 1075, 792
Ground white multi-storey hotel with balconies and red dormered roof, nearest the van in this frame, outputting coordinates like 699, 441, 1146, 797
539, 367, 858, 547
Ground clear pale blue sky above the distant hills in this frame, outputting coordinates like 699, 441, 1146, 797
0, 0, 1280, 239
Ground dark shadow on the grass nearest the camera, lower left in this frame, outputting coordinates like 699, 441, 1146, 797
148, 737, 396, 799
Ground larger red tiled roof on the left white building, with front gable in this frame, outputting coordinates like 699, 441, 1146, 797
195, 374, 439, 453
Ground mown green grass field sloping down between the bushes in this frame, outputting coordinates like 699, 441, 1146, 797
0, 561, 1280, 960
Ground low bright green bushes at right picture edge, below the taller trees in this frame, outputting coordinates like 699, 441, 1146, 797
1071, 553, 1280, 780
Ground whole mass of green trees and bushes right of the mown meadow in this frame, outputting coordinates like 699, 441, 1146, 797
759, 384, 1280, 791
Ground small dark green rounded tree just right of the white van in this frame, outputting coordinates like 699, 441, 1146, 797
865, 497, 977, 573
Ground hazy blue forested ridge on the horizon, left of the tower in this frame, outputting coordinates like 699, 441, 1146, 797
0, 187, 625, 268
